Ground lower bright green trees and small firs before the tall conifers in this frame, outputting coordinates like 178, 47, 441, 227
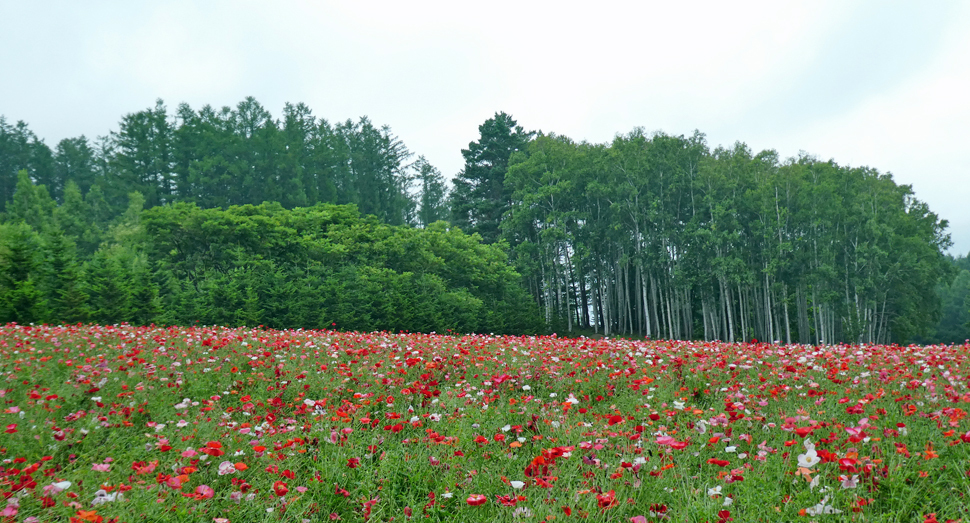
0, 176, 542, 333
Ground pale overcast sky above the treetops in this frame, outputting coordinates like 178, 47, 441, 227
0, 0, 970, 254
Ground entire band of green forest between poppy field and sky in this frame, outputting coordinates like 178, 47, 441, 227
0, 98, 970, 344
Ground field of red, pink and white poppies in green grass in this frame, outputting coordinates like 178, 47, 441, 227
0, 325, 970, 523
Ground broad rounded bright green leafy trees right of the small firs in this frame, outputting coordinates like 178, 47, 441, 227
142, 204, 538, 332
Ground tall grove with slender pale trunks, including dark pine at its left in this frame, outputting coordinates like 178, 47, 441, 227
452, 113, 968, 344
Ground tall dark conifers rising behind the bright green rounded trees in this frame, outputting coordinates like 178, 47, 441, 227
0, 97, 446, 225
